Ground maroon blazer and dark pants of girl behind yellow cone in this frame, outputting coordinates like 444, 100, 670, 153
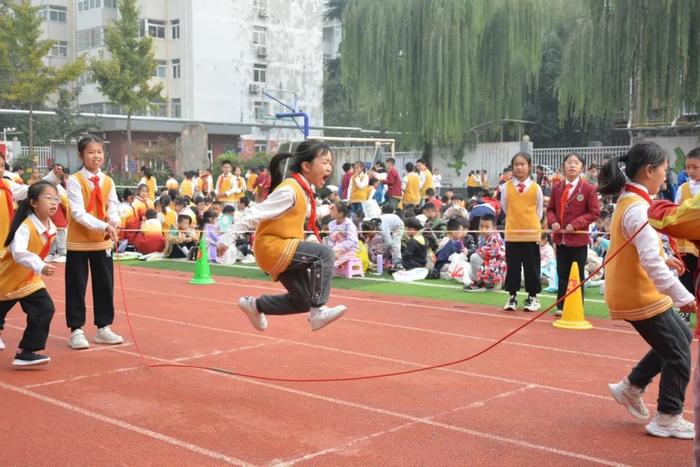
547, 177, 600, 310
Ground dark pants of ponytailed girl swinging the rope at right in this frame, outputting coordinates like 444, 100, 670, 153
628, 310, 693, 415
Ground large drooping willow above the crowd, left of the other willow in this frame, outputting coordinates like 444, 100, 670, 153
341, 0, 552, 145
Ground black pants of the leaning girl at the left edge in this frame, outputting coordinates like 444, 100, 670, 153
0, 289, 55, 352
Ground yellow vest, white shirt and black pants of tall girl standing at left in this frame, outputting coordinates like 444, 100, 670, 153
65, 168, 120, 330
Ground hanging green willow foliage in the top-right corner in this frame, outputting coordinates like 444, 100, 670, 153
559, 0, 700, 123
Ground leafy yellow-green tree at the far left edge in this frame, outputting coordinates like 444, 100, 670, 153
0, 0, 85, 148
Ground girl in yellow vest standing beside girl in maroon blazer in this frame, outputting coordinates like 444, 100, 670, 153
501, 152, 544, 311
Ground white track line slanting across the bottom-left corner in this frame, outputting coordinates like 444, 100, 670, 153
0, 381, 253, 467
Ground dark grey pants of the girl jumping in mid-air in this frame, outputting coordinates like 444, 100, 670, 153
256, 242, 335, 315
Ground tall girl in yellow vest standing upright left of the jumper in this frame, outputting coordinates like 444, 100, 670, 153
65, 136, 124, 349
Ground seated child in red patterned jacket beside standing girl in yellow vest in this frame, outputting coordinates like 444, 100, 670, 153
464, 214, 506, 292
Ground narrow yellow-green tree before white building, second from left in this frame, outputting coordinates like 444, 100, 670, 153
90, 0, 163, 155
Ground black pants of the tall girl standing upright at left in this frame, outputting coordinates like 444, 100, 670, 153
65, 250, 114, 331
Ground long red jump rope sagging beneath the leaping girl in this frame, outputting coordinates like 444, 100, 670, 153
117, 222, 648, 383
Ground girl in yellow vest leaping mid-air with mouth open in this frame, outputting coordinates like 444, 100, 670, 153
217, 141, 345, 331
